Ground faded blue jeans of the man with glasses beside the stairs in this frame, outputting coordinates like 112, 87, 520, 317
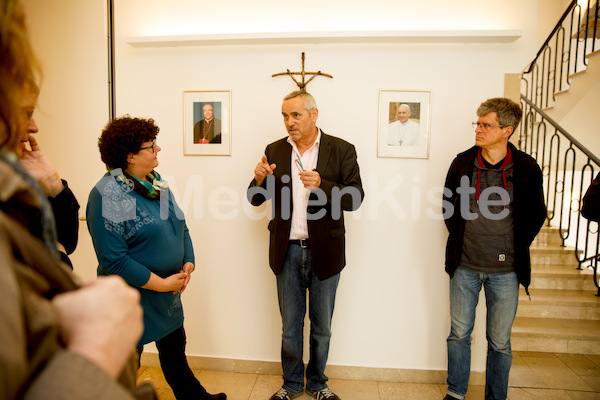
448, 267, 519, 400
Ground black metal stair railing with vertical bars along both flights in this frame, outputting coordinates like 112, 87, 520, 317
518, 0, 600, 296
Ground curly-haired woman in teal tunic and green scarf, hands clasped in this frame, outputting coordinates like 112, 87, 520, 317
86, 116, 227, 400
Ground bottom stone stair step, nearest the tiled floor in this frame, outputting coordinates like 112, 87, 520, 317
511, 317, 600, 355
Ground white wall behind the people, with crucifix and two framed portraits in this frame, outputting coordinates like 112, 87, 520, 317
28, 0, 537, 371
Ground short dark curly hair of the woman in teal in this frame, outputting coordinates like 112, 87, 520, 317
98, 115, 159, 170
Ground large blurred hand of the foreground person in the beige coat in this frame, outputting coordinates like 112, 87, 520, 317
52, 276, 144, 378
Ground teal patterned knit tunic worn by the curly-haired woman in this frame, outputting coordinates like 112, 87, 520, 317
86, 173, 194, 346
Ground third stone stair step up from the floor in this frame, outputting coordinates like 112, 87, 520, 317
529, 264, 597, 291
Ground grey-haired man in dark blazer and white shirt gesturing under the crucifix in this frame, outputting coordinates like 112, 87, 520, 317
247, 91, 364, 400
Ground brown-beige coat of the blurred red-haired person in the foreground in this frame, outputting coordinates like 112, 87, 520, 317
0, 162, 154, 399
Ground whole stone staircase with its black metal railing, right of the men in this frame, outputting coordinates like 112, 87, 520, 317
512, 0, 600, 355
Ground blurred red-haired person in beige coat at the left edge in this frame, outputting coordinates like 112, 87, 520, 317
0, 0, 155, 399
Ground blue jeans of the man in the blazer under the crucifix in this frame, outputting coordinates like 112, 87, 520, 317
277, 244, 340, 394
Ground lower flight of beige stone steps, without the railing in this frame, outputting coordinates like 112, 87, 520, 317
511, 227, 600, 355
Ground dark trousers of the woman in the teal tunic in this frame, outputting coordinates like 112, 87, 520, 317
138, 325, 206, 400
